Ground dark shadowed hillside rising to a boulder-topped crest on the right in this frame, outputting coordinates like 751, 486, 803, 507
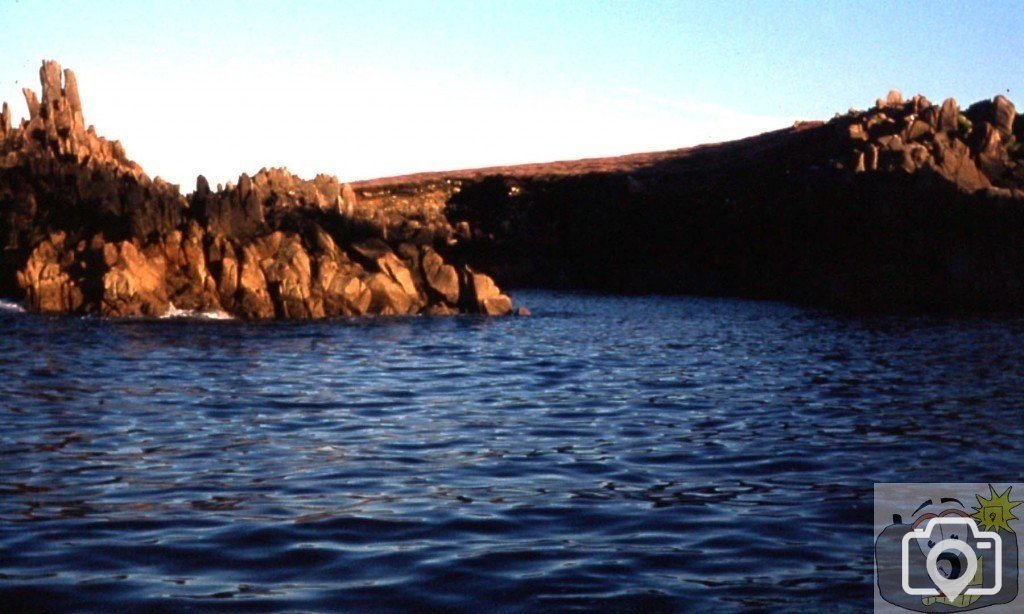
353, 92, 1024, 311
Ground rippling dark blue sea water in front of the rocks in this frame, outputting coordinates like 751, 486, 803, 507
0, 293, 1024, 611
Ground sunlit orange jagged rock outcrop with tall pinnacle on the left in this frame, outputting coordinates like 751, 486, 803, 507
0, 61, 512, 318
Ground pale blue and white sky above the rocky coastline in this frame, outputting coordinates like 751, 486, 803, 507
0, 0, 1024, 191
